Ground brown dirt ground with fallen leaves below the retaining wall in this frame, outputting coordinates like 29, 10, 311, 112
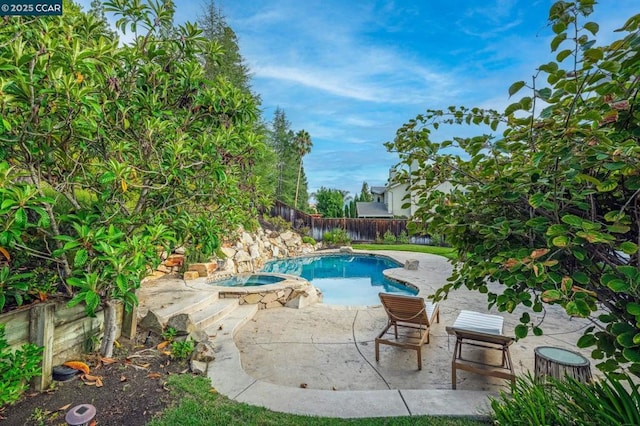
0, 333, 190, 426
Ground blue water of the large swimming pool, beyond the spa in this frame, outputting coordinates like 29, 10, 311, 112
262, 254, 418, 306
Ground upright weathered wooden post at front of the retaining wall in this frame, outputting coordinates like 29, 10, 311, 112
29, 303, 55, 392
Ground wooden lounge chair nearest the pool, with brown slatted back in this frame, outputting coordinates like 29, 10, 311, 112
376, 293, 440, 370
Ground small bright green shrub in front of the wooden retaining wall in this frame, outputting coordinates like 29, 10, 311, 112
0, 324, 42, 408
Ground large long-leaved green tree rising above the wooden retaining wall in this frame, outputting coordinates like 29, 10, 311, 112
0, 0, 268, 356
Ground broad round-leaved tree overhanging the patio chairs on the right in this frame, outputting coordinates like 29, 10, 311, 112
387, 0, 640, 375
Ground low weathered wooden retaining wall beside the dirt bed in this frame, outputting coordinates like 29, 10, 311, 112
0, 302, 137, 391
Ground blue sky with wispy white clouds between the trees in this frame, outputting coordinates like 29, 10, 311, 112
74, 0, 640, 196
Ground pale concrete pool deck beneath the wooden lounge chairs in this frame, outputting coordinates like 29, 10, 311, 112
140, 251, 595, 418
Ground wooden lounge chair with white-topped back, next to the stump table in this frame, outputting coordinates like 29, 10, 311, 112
446, 310, 516, 389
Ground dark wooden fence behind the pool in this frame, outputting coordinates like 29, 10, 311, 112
271, 201, 431, 244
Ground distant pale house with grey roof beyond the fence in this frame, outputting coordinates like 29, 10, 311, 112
356, 168, 453, 218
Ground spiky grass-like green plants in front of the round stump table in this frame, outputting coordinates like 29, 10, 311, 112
491, 375, 640, 426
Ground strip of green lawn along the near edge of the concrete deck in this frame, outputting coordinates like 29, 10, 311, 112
149, 374, 490, 426
